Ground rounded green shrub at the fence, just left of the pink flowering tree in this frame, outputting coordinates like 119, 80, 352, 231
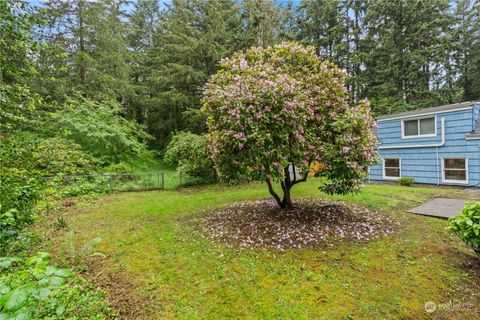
164, 132, 213, 177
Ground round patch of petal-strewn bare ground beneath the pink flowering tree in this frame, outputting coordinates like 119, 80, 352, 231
203, 199, 396, 251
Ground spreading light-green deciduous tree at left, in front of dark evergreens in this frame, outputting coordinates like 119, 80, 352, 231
52, 97, 152, 164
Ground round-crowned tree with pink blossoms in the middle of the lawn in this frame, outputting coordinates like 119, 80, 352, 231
203, 43, 377, 208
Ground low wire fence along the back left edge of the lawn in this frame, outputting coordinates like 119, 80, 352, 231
42, 170, 216, 196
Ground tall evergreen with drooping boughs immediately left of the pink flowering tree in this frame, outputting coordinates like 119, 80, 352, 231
147, 0, 241, 145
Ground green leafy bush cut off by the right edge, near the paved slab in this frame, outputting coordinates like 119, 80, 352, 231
448, 202, 480, 256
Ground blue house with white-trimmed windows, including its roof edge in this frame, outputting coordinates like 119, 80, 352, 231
370, 101, 480, 187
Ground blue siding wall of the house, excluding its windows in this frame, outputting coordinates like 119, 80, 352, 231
370, 105, 480, 186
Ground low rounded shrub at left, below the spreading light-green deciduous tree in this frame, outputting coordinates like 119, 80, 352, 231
33, 138, 95, 176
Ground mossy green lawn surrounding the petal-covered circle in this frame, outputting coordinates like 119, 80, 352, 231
39, 179, 480, 319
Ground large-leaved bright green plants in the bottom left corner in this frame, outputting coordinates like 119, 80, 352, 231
0, 252, 112, 320
